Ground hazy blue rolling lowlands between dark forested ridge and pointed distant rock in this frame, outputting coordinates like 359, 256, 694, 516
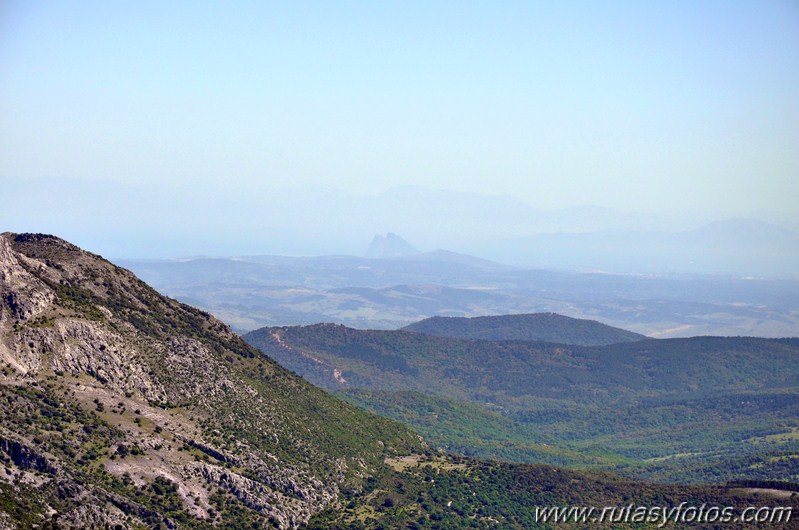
120, 245, 799, 338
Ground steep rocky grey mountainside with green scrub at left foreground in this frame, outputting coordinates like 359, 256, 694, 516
0, 233, 423, 528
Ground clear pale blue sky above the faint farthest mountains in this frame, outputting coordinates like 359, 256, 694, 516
0, 0, 799, 215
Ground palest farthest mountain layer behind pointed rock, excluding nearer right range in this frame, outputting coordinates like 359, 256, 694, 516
2, 173, 799, 260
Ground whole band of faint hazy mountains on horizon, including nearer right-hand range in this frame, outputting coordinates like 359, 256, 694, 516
7, 179, 799, 277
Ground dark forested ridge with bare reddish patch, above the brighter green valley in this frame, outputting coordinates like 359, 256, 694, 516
244, 324, 799, 400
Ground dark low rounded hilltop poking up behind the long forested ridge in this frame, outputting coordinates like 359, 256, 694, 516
402, 313, 646, 346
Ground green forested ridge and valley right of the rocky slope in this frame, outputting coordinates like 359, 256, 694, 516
244, 324, 799, 482
